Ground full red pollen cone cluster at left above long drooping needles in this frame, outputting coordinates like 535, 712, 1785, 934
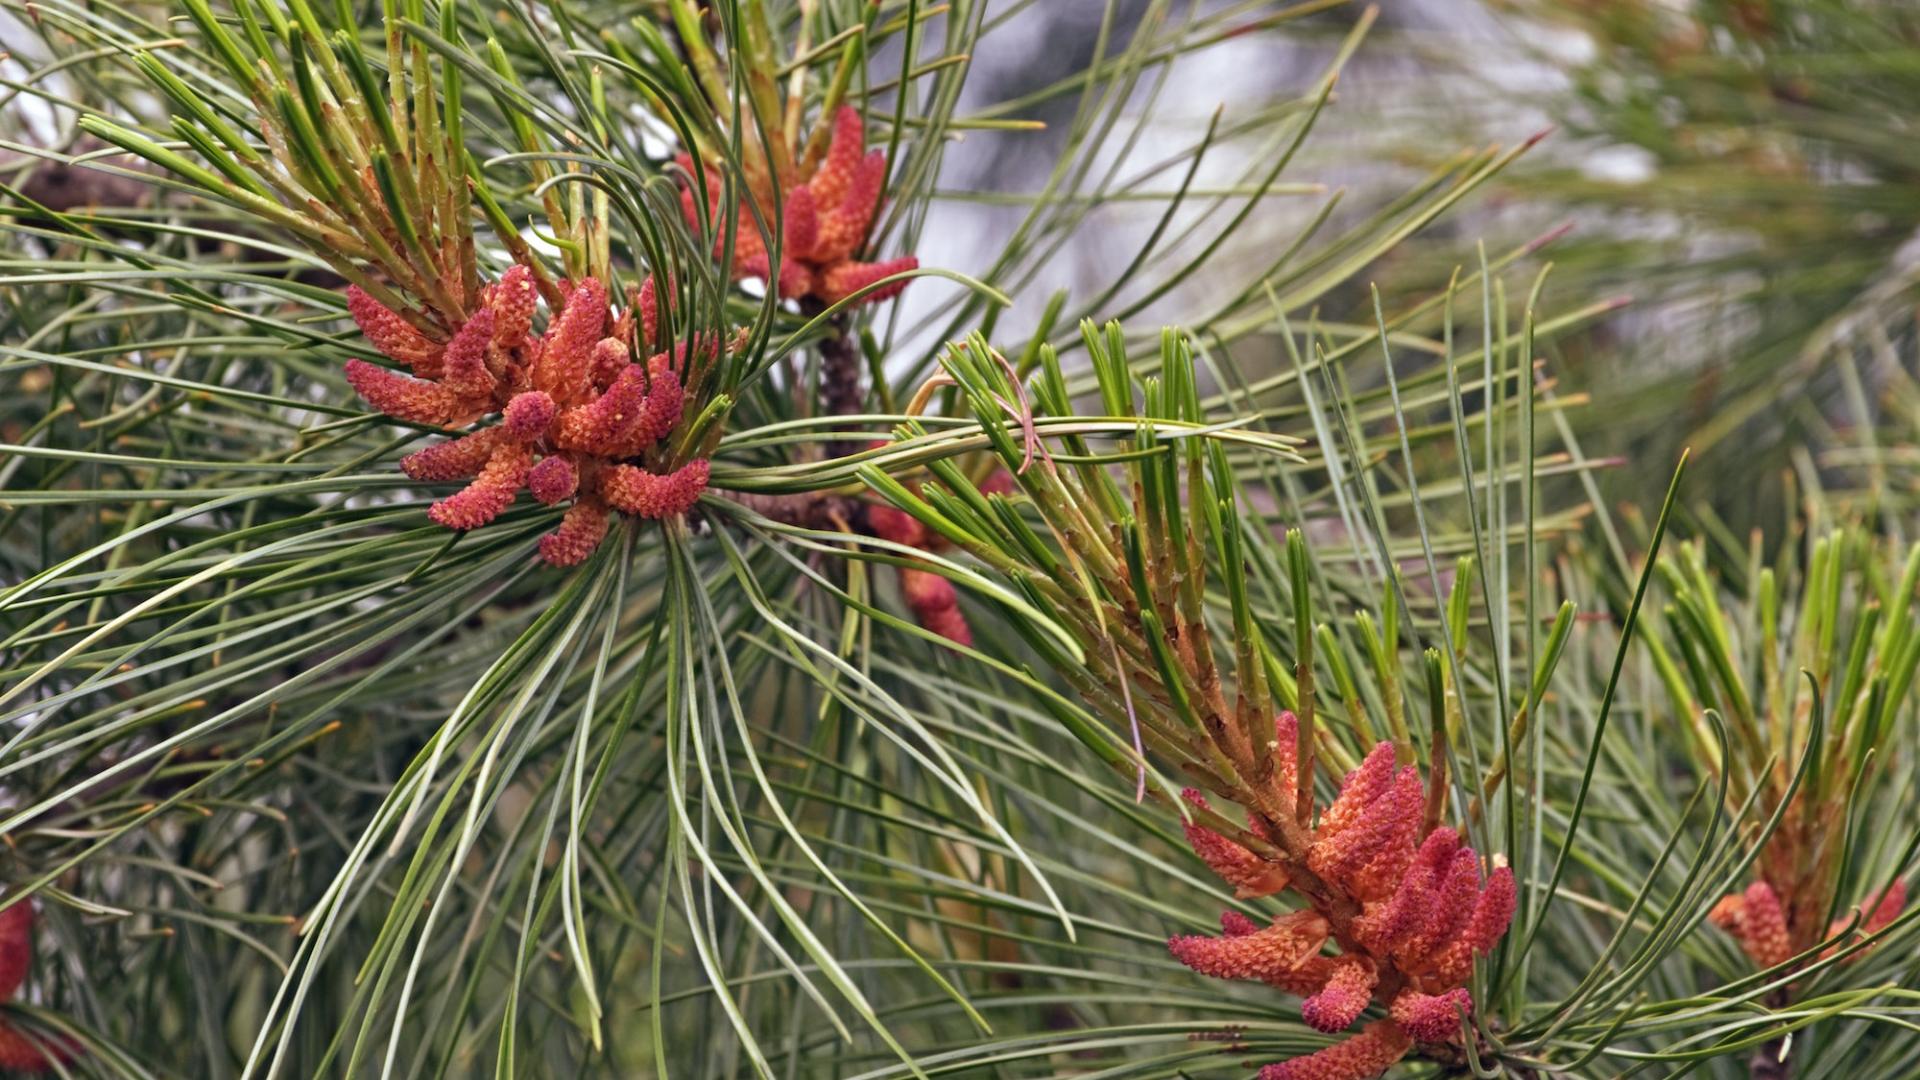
346, 265, 712, 567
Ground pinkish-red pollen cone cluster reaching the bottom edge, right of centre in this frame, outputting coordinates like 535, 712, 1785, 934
1167, 713, 1515, 1080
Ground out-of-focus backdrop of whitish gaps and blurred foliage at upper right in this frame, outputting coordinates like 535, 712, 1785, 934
902, 0, 1920, 544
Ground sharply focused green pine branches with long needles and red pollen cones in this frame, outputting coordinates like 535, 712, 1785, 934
0, 0, 1920, 1080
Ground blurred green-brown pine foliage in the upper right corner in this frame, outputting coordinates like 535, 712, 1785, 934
1473, 0, 1920, 528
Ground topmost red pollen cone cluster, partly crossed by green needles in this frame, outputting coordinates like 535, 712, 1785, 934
678, 106, 920, 304
